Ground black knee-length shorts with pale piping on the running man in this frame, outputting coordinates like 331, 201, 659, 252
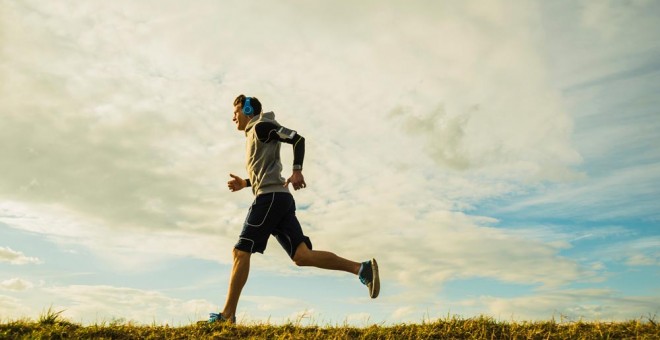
234, 192, 312, 259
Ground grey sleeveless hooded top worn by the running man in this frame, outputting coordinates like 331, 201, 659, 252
245, 112, 289, 196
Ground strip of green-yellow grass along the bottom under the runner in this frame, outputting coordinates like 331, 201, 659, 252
0, 310, 660, 339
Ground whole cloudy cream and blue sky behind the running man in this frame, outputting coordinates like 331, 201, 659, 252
0, 0, 660, 326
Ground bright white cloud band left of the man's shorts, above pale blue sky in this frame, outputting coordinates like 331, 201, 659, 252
0, 203, 235, 271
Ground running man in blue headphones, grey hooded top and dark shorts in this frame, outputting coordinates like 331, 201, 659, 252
208, 95, 380, 323
